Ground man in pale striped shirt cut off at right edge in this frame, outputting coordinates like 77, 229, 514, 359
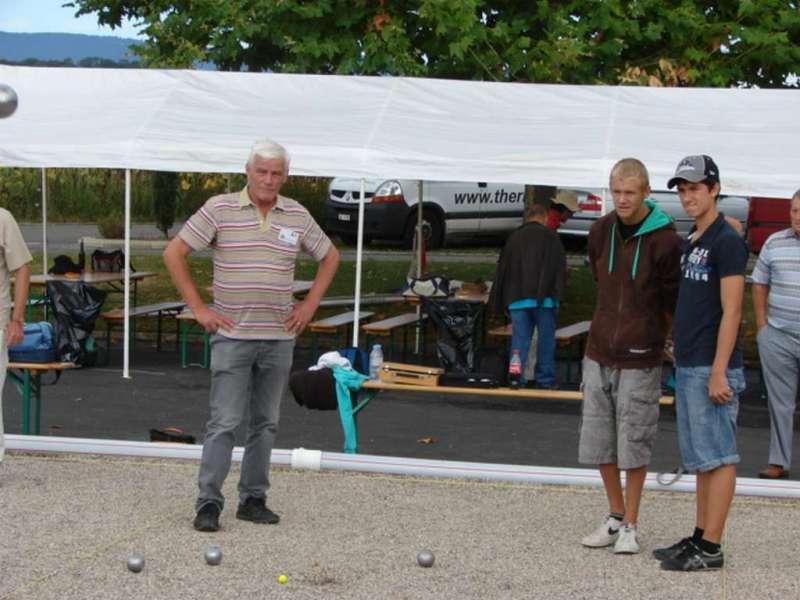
753, 190, 800, 479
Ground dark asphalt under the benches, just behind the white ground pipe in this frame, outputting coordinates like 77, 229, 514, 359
3, 342, 800, 476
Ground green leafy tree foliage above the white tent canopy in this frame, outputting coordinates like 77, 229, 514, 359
72, 0, 800, 87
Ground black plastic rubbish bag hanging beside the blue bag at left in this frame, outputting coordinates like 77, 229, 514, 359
47, 281, 106, 366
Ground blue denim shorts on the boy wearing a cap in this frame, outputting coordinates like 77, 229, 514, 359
675, 367, 745, 472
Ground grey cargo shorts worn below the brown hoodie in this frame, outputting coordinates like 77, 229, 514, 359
578, 358, 661, 469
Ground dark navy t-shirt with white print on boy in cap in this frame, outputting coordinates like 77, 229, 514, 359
673, 215, 748, 369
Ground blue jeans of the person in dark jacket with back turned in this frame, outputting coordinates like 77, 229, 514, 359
509, 308, 556, 386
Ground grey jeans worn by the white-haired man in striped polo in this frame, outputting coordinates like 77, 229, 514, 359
196, 334, 294, 510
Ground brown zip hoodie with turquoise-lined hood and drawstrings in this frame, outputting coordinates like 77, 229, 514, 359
586, 200, 681, 369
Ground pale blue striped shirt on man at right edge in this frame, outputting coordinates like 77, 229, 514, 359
753, 228, 800, 335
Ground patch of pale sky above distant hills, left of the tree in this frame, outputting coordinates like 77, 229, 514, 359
0, 0, 142, 38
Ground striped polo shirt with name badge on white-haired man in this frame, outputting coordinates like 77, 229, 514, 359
178, 188, 331, 340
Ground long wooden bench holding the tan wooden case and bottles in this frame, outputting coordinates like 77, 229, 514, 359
328, 380, 674, 454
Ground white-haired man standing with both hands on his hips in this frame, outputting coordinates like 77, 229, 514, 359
164, 141, 339, 531
